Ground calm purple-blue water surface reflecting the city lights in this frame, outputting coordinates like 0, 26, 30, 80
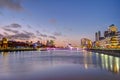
0, 50, 120, 80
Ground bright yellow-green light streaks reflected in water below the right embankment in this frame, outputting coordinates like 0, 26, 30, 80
95, 54, 120, 73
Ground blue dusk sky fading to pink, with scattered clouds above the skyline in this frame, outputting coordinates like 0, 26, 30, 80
0, 0, 120, 46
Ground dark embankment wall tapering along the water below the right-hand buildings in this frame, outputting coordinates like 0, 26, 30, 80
87, 49, 120, 57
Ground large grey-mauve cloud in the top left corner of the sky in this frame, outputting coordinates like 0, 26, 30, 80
0, 0, 23, 11
